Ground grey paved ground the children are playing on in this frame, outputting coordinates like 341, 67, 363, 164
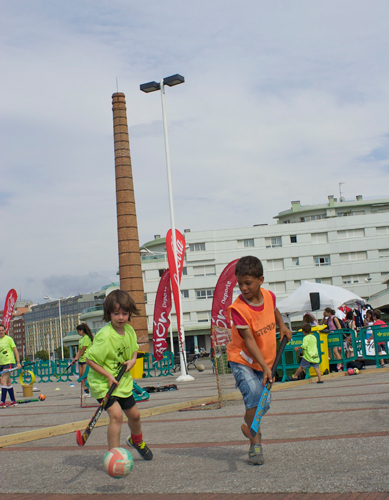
0, 365, 389, 500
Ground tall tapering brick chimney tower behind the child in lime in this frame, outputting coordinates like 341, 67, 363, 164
112, 92, 149, 352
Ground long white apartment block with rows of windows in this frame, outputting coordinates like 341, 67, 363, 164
141, 196, 389, 350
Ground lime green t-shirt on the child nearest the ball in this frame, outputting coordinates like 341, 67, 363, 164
87, 323, 139, 399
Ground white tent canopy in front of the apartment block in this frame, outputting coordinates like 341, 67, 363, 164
277, 281, 365, 316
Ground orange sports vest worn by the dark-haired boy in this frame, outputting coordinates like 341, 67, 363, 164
227, 288, 277, 371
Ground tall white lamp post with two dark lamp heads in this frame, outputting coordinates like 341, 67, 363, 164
140, 75, 194, 381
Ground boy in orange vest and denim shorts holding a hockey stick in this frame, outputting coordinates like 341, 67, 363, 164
227, 256, 292, 465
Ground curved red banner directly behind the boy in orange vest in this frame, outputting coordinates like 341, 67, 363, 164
211, 259, 239, 329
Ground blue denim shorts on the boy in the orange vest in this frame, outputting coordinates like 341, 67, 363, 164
229, 361, 271, 414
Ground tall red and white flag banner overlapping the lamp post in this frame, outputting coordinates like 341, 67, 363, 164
166, 229, 185, 351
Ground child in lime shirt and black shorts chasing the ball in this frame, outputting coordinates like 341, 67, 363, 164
86, 290, 153, 460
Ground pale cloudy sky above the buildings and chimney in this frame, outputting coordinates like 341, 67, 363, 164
0, 0, 389, 309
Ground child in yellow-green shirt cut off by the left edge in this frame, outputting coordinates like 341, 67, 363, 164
0, 323, 22, 408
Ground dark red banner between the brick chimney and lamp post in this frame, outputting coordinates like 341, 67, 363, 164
153, 269, 172, 361
